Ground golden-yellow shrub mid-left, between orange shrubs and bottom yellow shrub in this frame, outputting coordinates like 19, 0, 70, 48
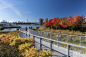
10, 37, 33, 48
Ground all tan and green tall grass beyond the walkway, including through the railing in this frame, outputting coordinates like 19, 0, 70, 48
39, 27, 86, 54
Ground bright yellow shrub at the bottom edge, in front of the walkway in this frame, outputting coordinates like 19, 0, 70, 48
22, 47, 53, 57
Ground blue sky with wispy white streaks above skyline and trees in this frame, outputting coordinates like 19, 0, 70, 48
0, 0, 86, 22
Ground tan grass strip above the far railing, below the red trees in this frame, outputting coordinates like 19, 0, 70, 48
38, 27, 86, 36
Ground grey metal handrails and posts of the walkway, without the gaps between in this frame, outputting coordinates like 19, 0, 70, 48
19, 30, 86, 56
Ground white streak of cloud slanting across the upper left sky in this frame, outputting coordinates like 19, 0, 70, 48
0, 0, 22, 17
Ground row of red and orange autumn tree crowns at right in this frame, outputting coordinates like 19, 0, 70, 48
44, 15, 84, 28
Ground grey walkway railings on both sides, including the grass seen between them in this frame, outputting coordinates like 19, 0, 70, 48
19, 29, 86, 57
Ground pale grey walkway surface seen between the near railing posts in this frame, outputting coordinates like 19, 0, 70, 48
20, 32, 86, 57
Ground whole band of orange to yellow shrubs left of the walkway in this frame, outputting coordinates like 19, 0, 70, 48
0, 34, 52, 57
